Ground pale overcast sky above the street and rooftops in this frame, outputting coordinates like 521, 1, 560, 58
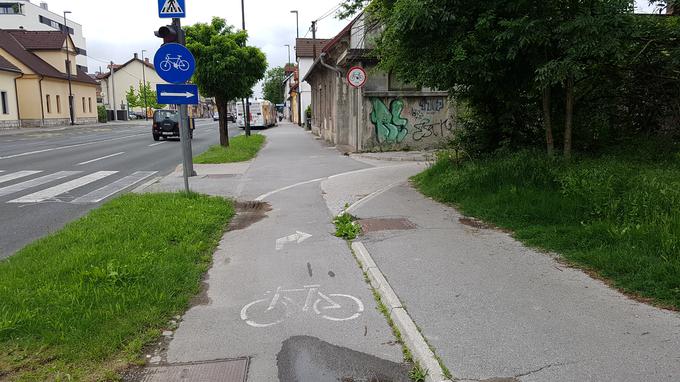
38, 0, 664, 96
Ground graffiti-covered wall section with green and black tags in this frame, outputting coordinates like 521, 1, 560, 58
371, 97, 454, 145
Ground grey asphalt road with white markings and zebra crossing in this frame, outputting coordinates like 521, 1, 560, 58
0, 120, 241, 259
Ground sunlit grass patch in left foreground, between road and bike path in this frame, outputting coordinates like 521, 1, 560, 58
0, 194, 234, 381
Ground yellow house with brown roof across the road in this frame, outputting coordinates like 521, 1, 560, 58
0, 29, 97, 127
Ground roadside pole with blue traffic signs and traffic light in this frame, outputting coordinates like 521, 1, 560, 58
154, 0, 198, 193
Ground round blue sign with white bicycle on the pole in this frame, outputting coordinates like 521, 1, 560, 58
153, 44, 196, 84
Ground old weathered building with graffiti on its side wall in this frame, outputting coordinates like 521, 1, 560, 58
303, 14, 455, 151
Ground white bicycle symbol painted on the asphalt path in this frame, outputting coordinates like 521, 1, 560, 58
241, 285, 364, 328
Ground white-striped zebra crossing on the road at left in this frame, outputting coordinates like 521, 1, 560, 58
0, 170, 158, 204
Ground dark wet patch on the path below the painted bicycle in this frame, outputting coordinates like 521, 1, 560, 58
277, 336, 410, 382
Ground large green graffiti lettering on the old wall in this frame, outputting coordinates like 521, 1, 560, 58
371, 98, 408, 144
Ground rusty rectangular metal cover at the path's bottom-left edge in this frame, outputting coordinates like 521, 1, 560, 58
134, 358, 248, 382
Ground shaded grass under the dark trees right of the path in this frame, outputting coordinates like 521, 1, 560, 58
413, 146, 680, 309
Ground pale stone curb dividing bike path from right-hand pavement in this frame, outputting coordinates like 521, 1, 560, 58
352, 241, 451, 382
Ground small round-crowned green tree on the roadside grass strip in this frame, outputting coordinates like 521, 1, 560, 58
185, 17, 267, 147
